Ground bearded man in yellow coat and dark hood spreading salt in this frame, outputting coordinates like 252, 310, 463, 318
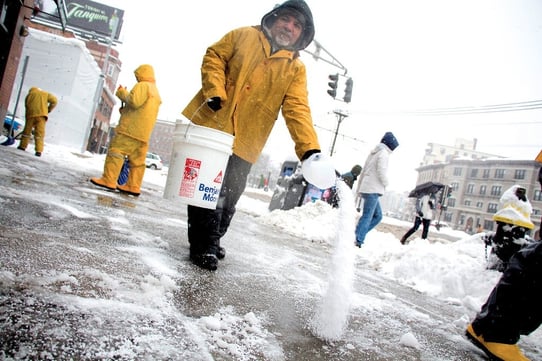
183, 0, 326, 270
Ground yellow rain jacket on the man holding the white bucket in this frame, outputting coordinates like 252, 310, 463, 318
183, 26, 320, 163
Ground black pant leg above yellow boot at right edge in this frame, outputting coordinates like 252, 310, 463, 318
472, 242, 542, 344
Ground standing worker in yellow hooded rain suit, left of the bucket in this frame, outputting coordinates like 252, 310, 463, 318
90, 64, 162, 197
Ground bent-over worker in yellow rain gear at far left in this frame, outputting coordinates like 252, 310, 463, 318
17, 87, 58, 157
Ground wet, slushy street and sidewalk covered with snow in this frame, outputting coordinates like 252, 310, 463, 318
0, 144, 542, 361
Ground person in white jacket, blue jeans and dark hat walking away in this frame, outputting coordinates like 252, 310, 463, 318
356, 132, 399, 247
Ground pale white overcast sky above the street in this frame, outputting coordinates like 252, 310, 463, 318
100, 0, 542, 191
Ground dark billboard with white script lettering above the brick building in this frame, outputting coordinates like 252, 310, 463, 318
36, 0, 124, 40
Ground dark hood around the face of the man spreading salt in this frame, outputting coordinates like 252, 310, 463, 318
262, 0, 315, 51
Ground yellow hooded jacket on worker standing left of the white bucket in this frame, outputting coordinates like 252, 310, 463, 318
115, 64, 162, 143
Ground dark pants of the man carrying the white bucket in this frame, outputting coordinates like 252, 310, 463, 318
188, 154, 252, 255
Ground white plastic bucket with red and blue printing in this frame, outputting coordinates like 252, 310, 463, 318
164, 120, 234, 209
